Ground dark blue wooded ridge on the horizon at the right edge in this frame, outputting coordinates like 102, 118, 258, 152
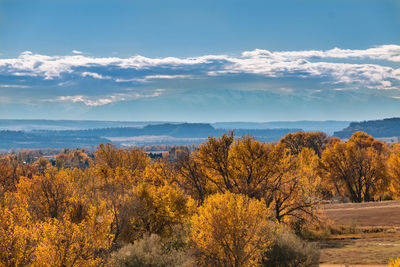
334, 118, 400, 138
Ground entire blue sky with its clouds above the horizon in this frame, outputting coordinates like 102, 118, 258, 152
0, 0, 400, 122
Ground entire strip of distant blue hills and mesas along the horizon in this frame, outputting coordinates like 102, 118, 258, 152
0, 118, 400, 151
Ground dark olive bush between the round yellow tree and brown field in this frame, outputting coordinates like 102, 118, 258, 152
262, 227, 319, 267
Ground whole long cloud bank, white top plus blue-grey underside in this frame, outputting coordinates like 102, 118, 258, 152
0, 45, 400, 107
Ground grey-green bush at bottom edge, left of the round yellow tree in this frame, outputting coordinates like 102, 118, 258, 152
110, 234, 194, 267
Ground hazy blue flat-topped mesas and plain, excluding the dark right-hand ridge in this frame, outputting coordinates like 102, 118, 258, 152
0, 123, 301, 151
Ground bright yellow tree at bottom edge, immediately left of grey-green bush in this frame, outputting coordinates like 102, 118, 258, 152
34, 205, 112, 267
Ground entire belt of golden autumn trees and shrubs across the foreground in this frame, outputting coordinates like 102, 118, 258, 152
0, 132, 400, 266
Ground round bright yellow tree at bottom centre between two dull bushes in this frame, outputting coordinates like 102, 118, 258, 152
191, 192, 272, 266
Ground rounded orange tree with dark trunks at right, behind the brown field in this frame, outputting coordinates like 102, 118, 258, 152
320, 132, 387, 202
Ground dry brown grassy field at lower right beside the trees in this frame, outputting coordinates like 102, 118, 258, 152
319, 201, 400, 267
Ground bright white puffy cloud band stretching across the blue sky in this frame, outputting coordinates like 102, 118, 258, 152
0, 45, 400, 90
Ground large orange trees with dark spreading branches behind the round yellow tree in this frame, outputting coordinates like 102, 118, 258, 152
188, 135, 318, 221
